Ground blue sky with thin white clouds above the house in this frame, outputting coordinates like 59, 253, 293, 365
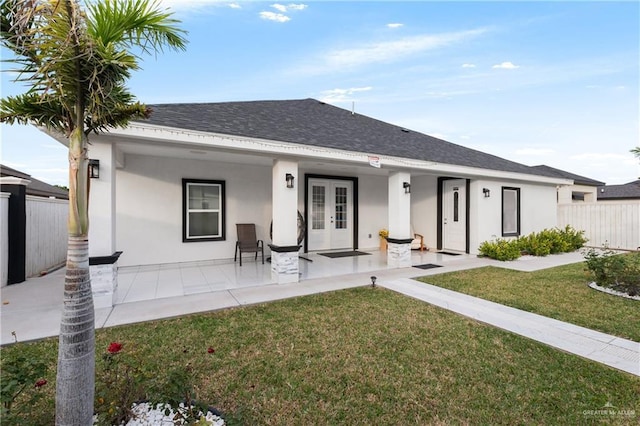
0, 0, 640, 185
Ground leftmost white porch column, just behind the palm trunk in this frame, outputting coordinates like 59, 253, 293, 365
89, 142, 120, 309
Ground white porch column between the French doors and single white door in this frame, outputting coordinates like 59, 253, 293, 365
387, 172, 413, 268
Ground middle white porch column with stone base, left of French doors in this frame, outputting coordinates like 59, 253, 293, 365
269, 160, 301, 284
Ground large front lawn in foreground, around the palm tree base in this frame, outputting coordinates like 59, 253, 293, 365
2, 287, 640, 425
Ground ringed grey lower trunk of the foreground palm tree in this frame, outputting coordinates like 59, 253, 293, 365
56, 236, 95, 426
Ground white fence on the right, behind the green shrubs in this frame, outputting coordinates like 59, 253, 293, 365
558, 201, 640, 250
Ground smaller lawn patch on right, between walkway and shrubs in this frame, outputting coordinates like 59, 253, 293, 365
420, 263, 640, 342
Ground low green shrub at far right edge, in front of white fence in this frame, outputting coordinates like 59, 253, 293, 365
585, 250, 640, 296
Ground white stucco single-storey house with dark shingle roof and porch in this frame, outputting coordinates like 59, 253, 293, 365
70, 99, 573, 294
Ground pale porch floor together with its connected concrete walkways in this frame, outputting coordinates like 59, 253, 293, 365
0, 251, 640, 376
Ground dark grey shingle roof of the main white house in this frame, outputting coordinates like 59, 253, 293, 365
136, 99, 560, 177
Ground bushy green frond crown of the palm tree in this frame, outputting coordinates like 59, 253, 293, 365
0, 0, 186, 135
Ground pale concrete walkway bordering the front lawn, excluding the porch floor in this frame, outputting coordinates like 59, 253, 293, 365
0, 253, 640, 376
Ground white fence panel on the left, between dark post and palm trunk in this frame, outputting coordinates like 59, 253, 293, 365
25, 195, 69, 277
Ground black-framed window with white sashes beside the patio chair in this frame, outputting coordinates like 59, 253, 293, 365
182, 179, 225, 242
